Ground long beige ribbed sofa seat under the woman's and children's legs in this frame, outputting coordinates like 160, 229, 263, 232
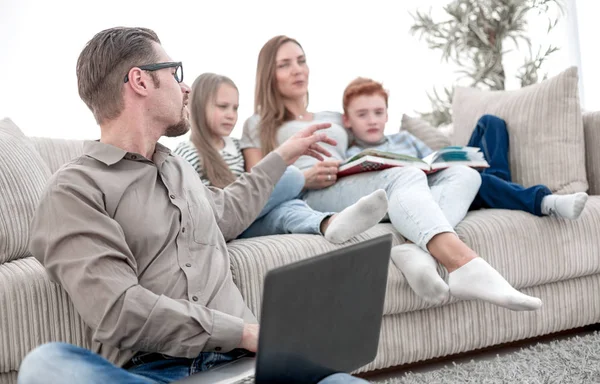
228, 196, 600, 317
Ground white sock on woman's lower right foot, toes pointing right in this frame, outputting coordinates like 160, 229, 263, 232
448, 257, 542, 311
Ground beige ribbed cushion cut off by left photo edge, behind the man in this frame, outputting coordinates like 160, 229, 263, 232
0, 119, 50, 264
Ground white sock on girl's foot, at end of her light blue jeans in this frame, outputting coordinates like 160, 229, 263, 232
324, 189, 388, 244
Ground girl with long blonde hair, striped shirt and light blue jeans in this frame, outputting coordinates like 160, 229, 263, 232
174, 73, 387, 243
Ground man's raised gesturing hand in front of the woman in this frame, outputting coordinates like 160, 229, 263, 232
275, 123, 337, 165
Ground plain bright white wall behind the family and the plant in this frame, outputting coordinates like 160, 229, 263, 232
0, 0, 584, 145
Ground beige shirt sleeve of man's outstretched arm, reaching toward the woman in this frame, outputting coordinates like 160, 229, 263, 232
209, 152, 287, 241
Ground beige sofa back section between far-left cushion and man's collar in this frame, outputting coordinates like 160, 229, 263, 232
29, 137, 84, 173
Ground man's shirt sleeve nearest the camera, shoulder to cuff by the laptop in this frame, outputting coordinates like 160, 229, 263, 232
30, 175, 244, 358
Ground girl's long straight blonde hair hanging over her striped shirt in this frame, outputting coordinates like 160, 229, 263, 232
190, 73, 237, 188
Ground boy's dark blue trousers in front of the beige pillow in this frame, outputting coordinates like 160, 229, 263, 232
468, 115, 552, 216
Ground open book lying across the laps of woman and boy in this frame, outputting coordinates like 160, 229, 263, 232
338, 146, 490, 177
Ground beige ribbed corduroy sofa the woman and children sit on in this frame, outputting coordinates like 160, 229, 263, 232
0, 82, 600, 383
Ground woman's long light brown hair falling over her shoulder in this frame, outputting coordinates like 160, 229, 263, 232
254, 35, 302, 155
